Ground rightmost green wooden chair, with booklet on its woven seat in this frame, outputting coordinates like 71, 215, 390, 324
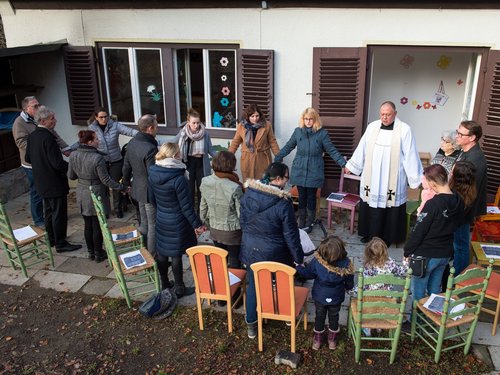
411, 263, 493, 363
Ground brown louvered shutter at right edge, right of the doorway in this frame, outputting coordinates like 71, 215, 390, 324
478, 51, 500, 195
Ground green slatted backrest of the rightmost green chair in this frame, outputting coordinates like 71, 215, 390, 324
441, 260, 493, 324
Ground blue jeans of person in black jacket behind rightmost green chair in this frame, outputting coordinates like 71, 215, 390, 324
411, 258, 450, 301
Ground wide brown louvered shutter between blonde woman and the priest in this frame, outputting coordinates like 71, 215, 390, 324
312, 48, 367, 191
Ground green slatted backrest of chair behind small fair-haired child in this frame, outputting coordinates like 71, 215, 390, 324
357, 268, 411, 323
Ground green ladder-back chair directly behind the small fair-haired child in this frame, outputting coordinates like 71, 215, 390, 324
347, 268, 411, 364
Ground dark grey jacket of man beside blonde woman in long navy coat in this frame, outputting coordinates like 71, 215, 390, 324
123, 132, 158, 203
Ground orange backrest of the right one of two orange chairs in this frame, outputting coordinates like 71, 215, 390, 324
250, 262, 297, 319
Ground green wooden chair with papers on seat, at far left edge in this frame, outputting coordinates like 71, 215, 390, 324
0, 203, 54, 277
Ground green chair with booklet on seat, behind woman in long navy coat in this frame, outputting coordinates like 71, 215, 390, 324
91, 193, 160, 308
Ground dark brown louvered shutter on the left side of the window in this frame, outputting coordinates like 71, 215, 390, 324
63, 46, 100, 125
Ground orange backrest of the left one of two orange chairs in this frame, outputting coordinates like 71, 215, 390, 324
186, 245, 230, 296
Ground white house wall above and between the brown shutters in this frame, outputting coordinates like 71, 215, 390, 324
0, 4, 500, 151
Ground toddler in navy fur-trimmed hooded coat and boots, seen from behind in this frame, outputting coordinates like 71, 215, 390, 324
297, 236, 354, 350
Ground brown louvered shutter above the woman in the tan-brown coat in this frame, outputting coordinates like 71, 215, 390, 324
238, 49, 274, 125
